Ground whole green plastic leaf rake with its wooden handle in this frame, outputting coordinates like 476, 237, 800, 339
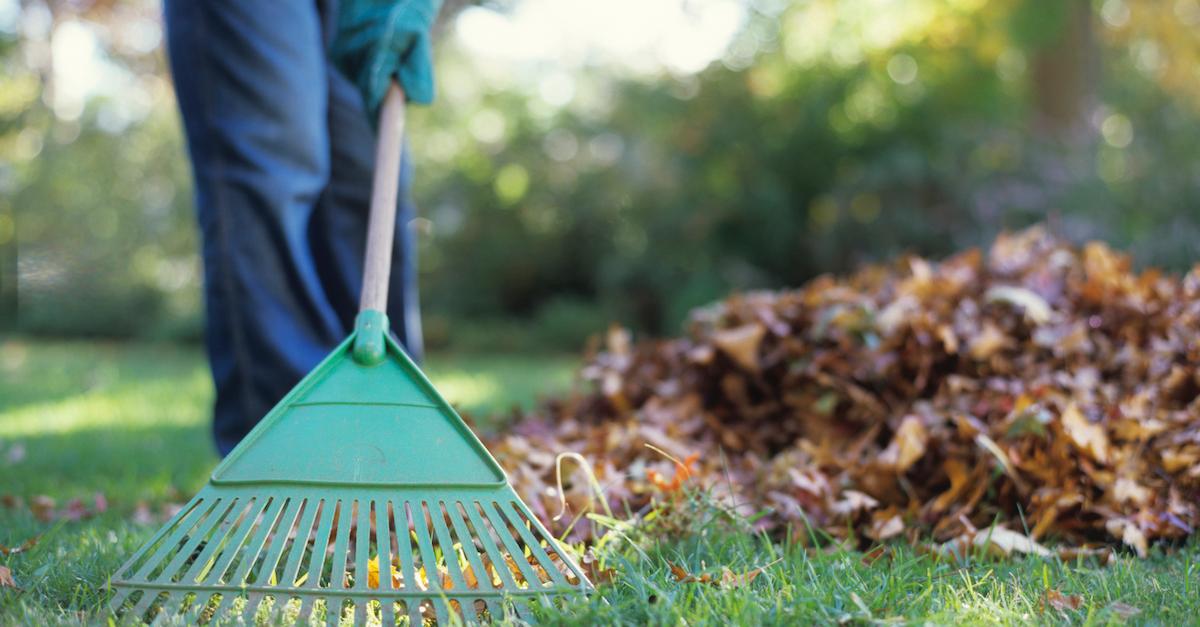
110, 85, 592, 626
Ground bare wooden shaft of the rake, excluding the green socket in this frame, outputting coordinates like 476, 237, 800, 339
359, 82, 404, 314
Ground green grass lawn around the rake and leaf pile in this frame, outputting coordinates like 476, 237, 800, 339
0, 340, 1200, 625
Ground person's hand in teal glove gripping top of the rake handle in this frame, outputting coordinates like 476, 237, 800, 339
330, 0, 442, 115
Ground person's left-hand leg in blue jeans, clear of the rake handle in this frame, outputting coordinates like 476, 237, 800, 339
166, 0, 347, 454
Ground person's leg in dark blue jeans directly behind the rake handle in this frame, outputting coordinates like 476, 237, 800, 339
310, 14, 422, 360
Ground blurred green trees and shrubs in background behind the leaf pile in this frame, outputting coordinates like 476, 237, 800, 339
0, 0, 1200, 350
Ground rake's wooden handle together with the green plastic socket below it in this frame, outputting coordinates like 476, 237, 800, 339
353, 82, 404, 366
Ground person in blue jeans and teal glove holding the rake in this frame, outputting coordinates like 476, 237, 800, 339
164, 0, 440, 455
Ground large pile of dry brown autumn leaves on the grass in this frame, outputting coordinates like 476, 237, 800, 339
488, 223, 1200, 555
